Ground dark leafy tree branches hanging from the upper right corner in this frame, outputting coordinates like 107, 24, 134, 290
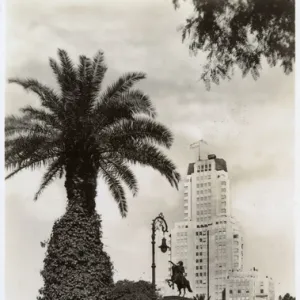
173, 0, 295, 89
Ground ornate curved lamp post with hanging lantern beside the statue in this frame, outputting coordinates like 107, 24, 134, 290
151, 213, 170, 289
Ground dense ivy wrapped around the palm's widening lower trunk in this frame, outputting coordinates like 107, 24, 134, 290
37, 205, 113, 300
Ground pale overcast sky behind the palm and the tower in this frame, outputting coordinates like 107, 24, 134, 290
6, 0, 295, 300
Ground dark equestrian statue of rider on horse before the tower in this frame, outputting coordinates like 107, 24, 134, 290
166, 261, 193, 297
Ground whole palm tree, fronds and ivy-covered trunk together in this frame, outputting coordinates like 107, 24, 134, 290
5, 50, 180, 299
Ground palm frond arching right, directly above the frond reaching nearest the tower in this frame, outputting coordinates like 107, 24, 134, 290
99, 117, 173, 148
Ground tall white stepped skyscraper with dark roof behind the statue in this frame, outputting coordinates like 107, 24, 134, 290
171, 155, 243, 300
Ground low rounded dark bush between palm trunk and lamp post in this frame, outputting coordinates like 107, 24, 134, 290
106, 280, 162, 300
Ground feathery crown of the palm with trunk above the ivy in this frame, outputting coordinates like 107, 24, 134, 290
5, 50, 180, 217
